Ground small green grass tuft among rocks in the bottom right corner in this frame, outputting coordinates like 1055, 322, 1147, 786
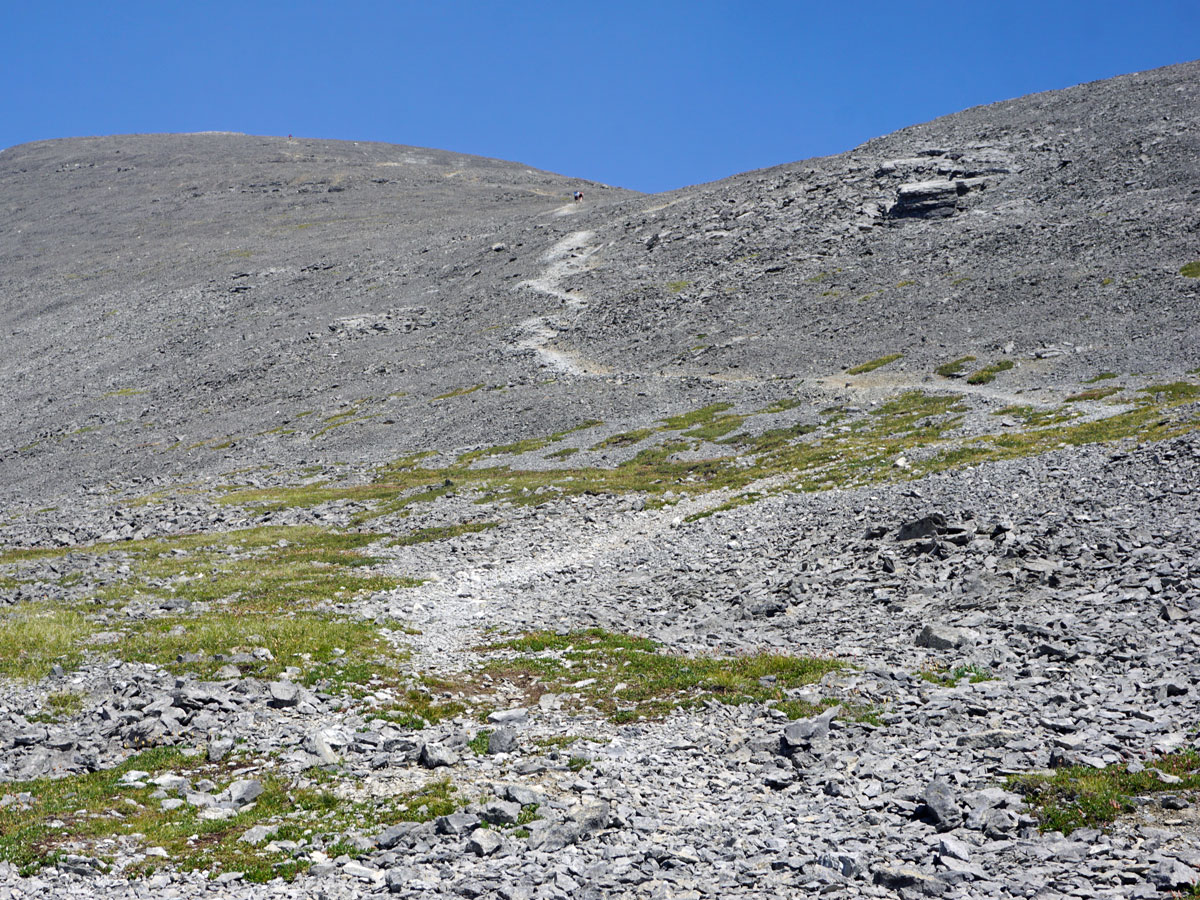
1008, 750, 1200, 834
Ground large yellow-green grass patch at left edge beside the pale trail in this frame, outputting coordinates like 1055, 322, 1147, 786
0, 526, 419, 682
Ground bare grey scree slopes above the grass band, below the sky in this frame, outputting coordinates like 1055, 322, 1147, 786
0, 64, 1200, 508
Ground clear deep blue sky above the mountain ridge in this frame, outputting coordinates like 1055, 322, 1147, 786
7, 0, 1200, 191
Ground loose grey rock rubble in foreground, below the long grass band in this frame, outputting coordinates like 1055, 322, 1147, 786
2, 427, 1200, 898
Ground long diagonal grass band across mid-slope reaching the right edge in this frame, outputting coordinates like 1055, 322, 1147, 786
206, 381, 1198, 535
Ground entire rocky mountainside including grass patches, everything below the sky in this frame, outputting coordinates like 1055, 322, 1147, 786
0, 62, 1200, 900
